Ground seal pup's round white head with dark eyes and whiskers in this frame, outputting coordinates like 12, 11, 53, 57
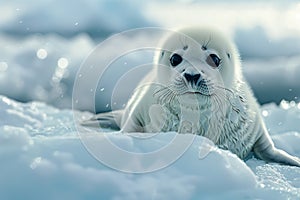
155, 27, 242, 99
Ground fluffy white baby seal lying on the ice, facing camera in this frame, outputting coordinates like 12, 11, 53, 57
83, 27, 300, 167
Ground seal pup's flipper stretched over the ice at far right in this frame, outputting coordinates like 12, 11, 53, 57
253, 135, 300, 167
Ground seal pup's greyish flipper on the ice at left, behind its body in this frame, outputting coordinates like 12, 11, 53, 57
81, 110, 124, 130
